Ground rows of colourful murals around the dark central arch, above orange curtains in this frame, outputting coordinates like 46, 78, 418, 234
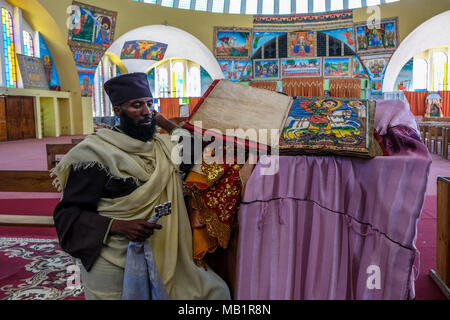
213, 11, 399, 95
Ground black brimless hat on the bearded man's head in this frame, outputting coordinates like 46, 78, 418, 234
104, 72, 153, 106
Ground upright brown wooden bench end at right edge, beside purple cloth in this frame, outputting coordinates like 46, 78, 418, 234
429, 177, 450, 299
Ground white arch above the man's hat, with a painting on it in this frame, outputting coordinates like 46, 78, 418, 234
102, 25, 223, 80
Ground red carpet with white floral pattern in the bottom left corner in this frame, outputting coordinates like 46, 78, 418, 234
0, 238, 84, 300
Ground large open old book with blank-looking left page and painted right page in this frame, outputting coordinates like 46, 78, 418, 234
185, 80, 383, 158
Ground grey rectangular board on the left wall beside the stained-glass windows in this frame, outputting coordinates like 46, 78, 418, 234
16, 53, 49, 90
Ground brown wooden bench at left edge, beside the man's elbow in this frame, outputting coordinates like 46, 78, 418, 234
0, 171, 57, 227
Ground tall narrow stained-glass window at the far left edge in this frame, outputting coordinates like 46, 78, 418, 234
2, 8, 17, 88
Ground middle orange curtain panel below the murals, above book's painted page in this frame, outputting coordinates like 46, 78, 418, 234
283, 78, 324, 97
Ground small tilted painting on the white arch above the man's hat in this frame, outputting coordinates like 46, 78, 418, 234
120, 40, 167, 61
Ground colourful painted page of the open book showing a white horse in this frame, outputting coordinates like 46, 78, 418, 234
280, 97, 380, 157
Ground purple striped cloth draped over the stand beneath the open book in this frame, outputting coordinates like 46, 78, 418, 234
235, 100, 431, 299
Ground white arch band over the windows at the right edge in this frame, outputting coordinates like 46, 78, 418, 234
383, 10, 450, 92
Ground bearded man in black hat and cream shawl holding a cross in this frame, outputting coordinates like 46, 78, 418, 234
52, 73, 230, 299
